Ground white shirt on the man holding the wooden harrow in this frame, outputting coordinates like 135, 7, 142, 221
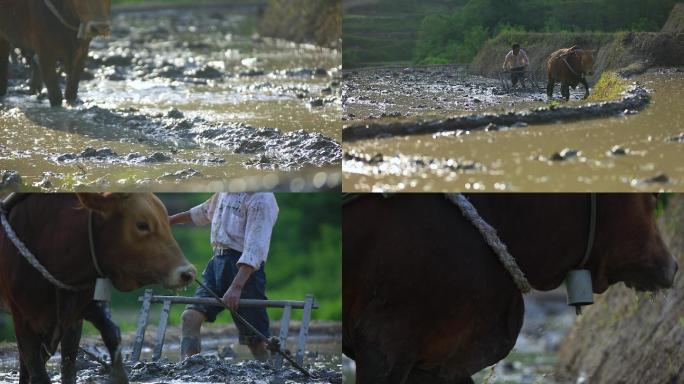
190, 192, 278, 269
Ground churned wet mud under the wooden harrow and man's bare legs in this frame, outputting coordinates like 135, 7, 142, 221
0, 322, 342, 384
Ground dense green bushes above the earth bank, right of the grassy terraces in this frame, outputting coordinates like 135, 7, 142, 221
414, 0, 676, 64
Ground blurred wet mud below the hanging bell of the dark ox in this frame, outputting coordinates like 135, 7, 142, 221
342, 288, 576, 384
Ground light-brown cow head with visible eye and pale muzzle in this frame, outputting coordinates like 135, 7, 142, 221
78, 193, 197, 291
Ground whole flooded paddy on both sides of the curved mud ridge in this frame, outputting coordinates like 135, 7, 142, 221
343, 69, 684, 192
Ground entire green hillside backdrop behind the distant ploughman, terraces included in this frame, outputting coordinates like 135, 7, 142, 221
343, 0, 677, 68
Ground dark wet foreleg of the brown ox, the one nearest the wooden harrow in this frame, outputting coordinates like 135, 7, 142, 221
85, 301, 128, 384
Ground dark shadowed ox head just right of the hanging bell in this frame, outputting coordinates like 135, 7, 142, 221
592, 193, 677, 293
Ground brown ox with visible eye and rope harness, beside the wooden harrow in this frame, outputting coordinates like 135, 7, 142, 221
0, 194, 196, 383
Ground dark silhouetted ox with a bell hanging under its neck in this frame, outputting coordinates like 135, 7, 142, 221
342, 194, 677, 384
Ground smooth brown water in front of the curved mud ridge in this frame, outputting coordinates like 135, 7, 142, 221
343, 70, 684, 191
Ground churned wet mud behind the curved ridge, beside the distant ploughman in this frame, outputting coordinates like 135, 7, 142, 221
342, 65, 584, 124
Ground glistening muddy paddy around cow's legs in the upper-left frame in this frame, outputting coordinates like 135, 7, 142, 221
0, 7, 341, 190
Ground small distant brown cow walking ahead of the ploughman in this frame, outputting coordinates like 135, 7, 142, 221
546, 45, 594, 101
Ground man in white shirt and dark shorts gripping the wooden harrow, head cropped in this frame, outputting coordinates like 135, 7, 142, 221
169, 193, 278, 361
